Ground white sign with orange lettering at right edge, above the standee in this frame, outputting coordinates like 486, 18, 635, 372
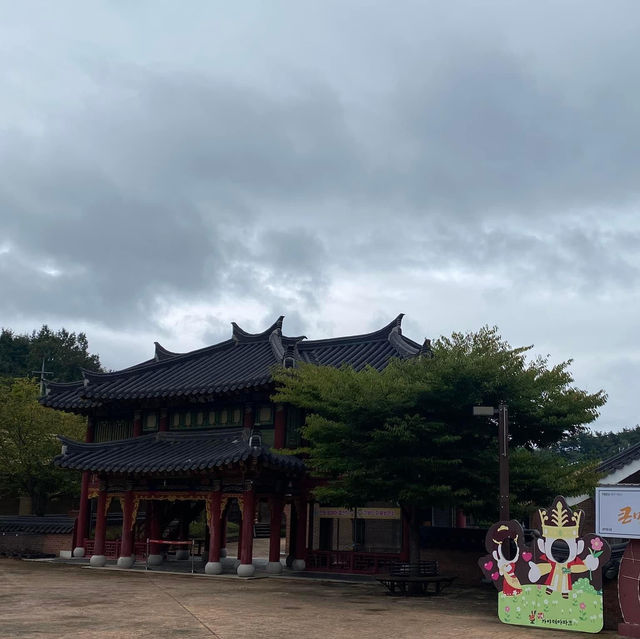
596, 484, 640, 539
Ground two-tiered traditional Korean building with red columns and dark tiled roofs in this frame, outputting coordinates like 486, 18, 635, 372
41, 315, 423, 576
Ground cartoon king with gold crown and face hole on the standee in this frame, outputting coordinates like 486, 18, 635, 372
529, 497, 599, 599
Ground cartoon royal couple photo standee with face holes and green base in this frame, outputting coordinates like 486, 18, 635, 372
478, 497, 612, 632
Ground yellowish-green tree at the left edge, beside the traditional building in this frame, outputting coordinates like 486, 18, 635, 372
0, 378, 85, 515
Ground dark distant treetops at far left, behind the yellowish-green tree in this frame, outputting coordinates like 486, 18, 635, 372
0, 324, 102, 382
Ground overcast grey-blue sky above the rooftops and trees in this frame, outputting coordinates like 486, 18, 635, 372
0, 0, 640, 429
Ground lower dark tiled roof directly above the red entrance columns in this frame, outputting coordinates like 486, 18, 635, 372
53, 428, 305, 474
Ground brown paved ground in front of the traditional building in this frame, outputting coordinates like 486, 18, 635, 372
0, 559, 616, 639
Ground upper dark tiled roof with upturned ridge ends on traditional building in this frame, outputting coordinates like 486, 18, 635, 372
42, 315, 420, 411
